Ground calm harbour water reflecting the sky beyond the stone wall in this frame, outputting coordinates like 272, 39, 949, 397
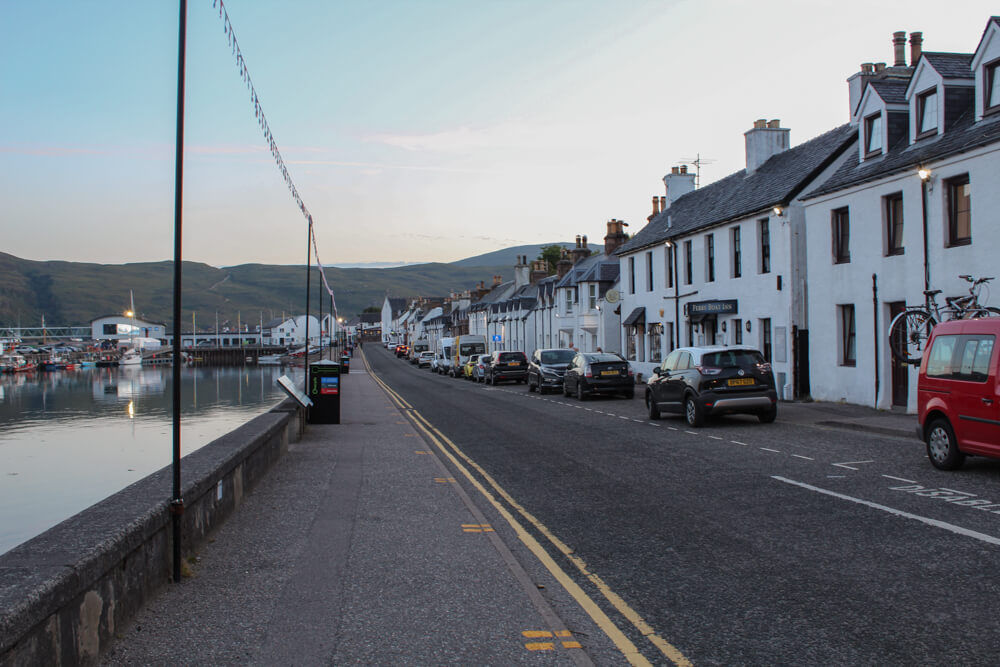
0, 366, 303, 553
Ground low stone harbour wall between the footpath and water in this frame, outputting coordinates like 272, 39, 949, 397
0, 399, 305, 667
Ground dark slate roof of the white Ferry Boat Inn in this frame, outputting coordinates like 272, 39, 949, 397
615, 123, 857, 255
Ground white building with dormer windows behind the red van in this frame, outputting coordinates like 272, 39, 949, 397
805, 22, 1000, 412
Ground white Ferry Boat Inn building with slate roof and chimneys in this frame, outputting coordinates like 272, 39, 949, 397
617, 120, 854, 399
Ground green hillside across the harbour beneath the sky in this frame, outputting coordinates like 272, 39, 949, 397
0, 253, 513, 328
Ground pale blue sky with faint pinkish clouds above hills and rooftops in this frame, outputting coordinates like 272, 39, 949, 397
0, 0, 996, 265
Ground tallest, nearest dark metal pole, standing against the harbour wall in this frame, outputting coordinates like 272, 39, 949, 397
170, 0, 187, 583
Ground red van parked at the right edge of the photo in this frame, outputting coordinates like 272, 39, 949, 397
917, 317, 1000, 470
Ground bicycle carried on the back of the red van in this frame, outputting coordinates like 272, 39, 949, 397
889, 275, 1000, 365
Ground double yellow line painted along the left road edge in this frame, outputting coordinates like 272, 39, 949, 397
364, 357, 692, 667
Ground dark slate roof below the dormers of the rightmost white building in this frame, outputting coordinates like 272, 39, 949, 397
802, 109, 1000, 199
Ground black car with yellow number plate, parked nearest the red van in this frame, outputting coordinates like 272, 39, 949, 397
646, 345, 778, 427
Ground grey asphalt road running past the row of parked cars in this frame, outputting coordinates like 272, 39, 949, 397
365, 345, 1000, 666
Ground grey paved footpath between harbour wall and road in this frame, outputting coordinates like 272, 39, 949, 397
102, 358, 627, 666
